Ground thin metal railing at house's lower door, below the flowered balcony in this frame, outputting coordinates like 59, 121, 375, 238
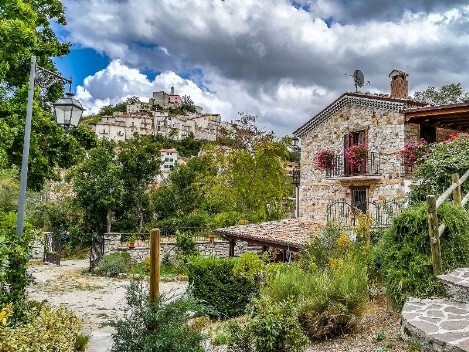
327, 199, 404, 227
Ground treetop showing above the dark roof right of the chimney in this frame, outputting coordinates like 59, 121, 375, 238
414, 83, 469, 105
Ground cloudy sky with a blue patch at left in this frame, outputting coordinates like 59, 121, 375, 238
55, 0, 469, 136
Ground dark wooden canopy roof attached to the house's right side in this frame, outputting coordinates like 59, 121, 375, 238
403, 102, 469, 132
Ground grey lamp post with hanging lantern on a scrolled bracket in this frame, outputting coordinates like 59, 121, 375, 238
16, 56, 84, 237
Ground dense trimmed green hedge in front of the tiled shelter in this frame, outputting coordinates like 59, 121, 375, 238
189, 257, 259, 319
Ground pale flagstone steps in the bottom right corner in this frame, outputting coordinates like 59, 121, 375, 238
401, 268, 469, 352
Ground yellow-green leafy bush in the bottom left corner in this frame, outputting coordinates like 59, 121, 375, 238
0, 303, 84, 352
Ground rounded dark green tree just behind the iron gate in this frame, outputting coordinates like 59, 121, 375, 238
70, 140, 125, 232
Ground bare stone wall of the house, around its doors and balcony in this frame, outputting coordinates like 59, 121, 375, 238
300, 104, 406, 224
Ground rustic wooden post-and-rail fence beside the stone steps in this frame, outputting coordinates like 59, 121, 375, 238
427, 170, 469, 275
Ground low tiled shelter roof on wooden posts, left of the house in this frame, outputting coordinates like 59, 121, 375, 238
214, 219, 319, 258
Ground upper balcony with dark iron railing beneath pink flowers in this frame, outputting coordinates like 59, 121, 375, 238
326, 152, 381, 179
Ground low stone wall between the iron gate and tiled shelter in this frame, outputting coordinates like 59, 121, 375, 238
104, 234, 262, 261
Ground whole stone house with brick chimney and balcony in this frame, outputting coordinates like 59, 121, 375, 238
294, 70, 454, 225
